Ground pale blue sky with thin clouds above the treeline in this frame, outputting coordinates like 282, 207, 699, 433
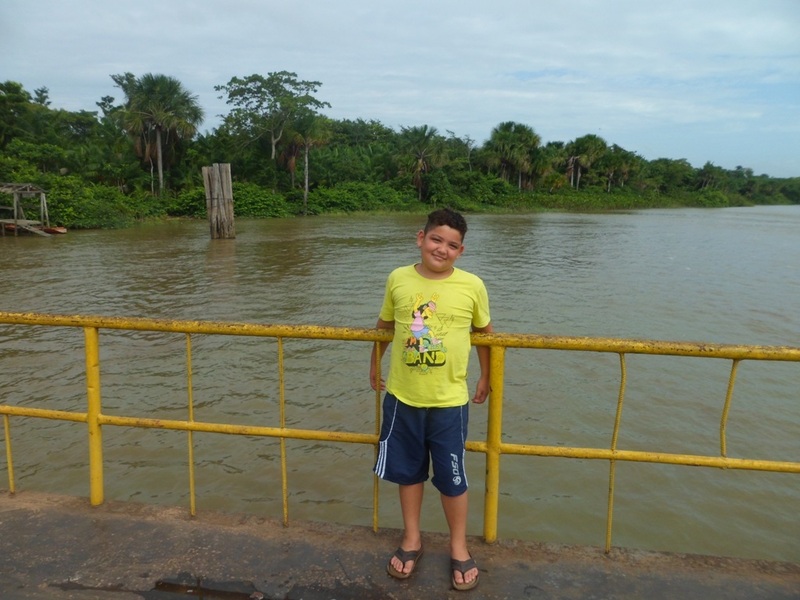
0, 0, 800, 177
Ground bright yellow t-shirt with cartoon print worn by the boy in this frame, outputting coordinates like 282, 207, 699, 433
380, 265, 491, 408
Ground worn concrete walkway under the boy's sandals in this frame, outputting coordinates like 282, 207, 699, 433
0, 493, 800, 600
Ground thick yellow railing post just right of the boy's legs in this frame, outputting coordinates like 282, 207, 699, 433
483, 346, 506, 544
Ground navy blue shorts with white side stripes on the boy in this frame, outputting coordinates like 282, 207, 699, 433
374, 392, 469, 496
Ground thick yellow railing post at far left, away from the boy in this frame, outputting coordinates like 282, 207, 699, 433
83, 327, 103, 506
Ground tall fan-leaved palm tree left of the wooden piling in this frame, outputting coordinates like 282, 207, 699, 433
111, 73, 203, 195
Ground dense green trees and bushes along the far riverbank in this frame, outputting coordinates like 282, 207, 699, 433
0, 71, 800, 228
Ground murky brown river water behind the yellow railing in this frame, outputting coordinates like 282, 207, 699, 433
0, 207, 800, 561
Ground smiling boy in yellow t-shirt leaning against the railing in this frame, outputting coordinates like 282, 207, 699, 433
370, 209, 492, 590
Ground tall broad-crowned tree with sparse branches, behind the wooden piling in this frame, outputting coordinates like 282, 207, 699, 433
214, 71, 330, 160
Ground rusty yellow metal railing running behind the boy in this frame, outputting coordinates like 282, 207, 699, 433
0, 312, 800, 551
